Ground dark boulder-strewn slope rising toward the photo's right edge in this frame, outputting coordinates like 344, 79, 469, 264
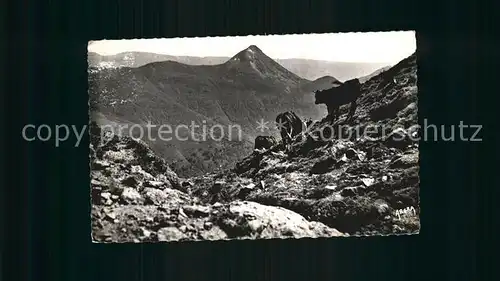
188, 54, 420, 235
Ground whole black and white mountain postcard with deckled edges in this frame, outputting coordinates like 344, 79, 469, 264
87, 31, 418, 243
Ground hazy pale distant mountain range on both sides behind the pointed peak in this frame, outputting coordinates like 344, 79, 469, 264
88, 52, 387, 81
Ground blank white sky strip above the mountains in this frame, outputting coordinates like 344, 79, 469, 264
88, 31, 417, 64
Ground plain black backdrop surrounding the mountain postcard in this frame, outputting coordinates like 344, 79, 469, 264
0, 0, 492, 281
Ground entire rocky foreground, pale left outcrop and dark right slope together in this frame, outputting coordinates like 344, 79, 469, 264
91, 55, 420, 242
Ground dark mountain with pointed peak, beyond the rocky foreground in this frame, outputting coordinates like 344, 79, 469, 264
89, 46, 325, 175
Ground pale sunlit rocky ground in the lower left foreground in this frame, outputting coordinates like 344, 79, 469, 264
91, 128, 345, 242
